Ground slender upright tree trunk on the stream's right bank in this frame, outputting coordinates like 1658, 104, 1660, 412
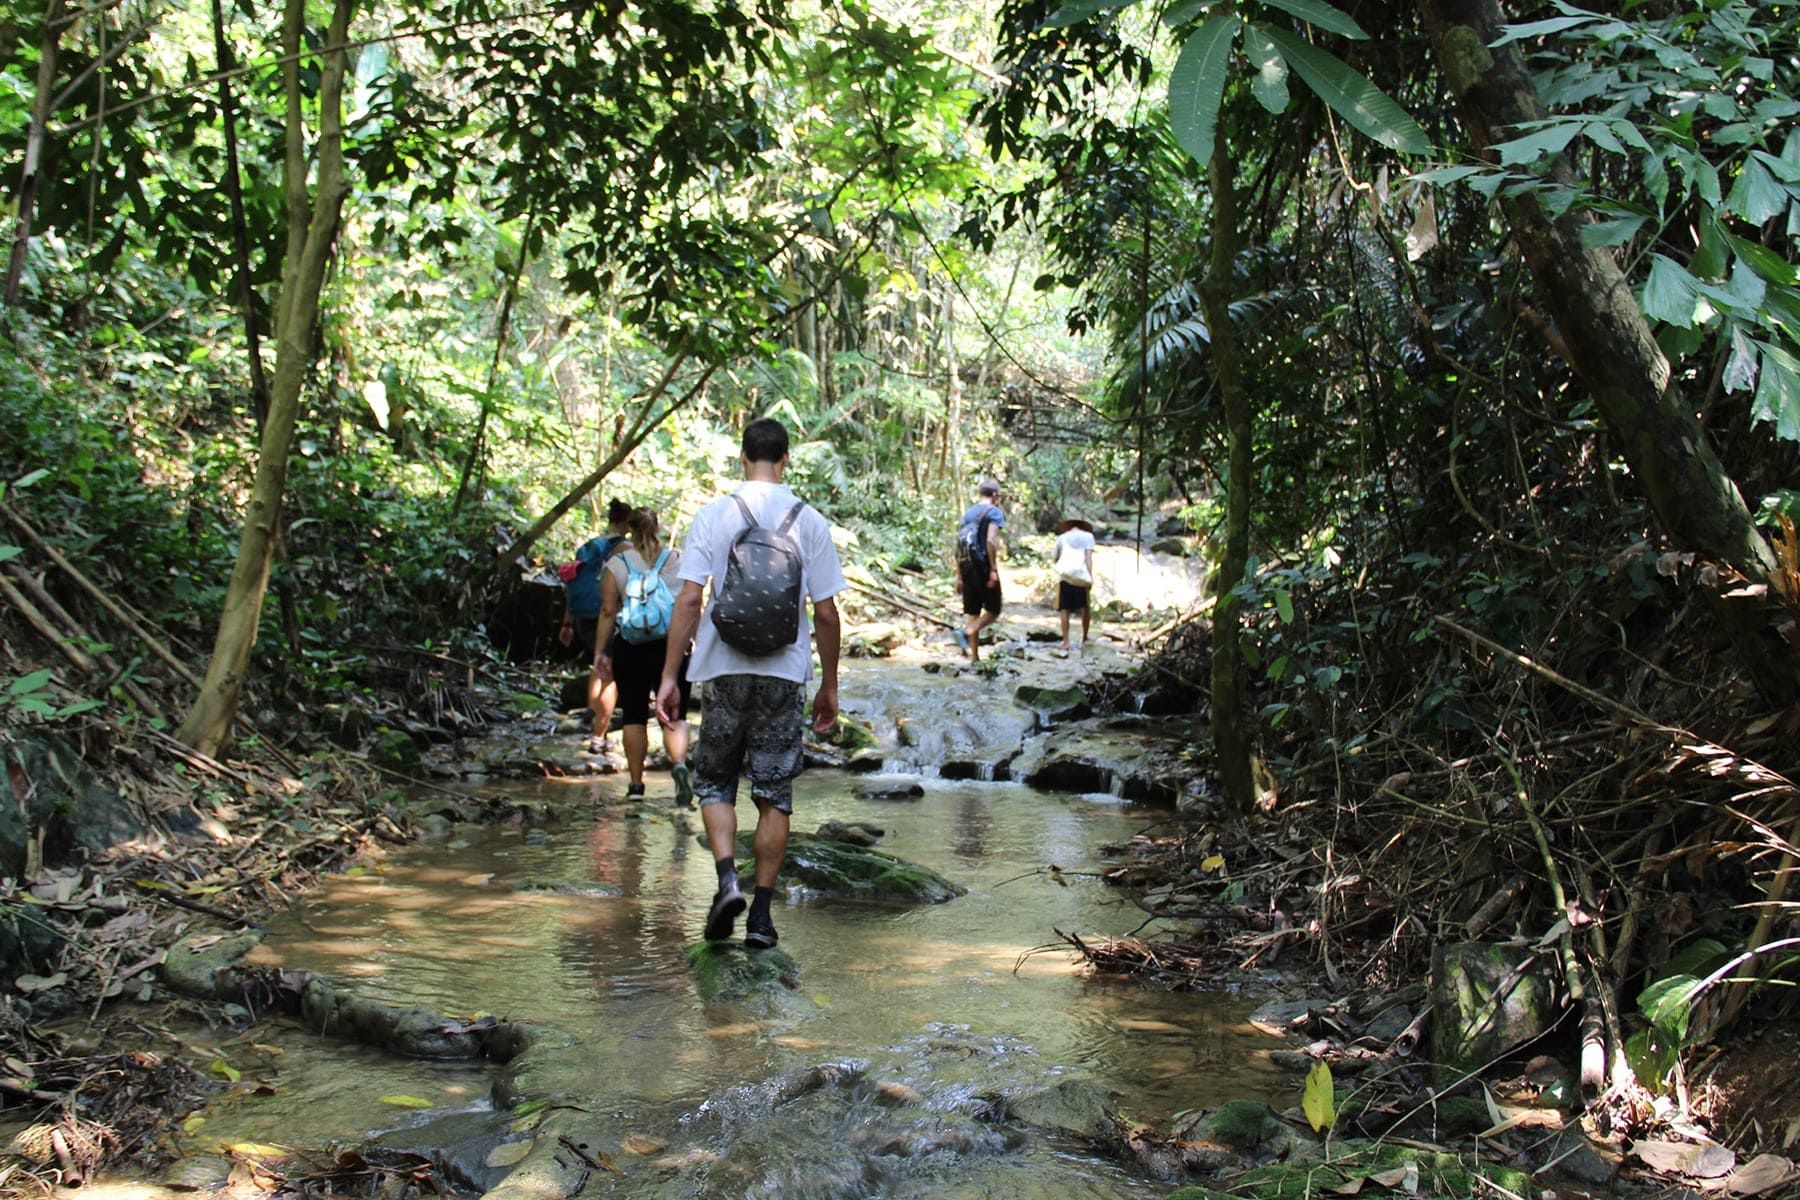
1201, 146, 1256, 813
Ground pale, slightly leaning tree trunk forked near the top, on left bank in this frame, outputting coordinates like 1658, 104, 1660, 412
178, 0, 355, 757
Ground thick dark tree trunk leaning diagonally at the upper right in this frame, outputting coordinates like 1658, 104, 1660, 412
1418, 0, 1800, 705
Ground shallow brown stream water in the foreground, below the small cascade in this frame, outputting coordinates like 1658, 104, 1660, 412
175, 662, 1291, 1196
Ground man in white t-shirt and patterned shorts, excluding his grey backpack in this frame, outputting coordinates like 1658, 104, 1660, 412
657, 417, 848, 950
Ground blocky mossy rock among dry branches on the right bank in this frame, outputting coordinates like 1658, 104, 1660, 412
1431, 943, 1555, 1076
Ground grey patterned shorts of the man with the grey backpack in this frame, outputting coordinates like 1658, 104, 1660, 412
688, 675, 806, 813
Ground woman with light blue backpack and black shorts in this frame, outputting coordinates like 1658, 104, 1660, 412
594, 509, 693, 808
